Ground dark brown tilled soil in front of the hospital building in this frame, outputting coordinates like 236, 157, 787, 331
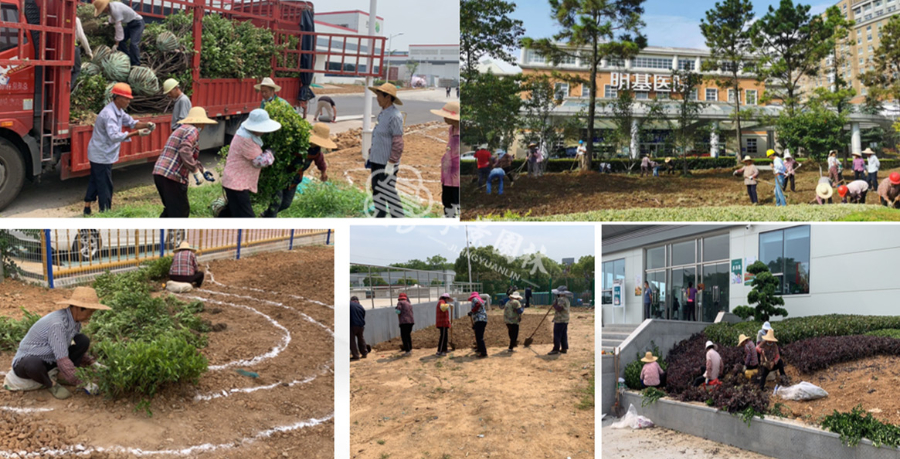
460, 165, 900, 220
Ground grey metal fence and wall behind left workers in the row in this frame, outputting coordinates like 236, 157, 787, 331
350, 263, 482, 309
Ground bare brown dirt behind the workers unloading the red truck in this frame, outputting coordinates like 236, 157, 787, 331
325, 121, 448, 202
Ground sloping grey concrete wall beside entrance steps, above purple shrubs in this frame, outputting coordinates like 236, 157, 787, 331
600, 319, 711, 413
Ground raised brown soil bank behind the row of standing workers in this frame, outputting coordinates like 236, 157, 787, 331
373, 308, 579, 351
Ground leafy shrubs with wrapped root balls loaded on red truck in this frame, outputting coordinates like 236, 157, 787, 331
70, 4, 286, 122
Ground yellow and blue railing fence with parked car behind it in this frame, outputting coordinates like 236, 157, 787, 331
9, 229, 334, 288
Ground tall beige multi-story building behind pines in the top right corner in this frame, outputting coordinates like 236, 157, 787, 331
802, 0, 900, 103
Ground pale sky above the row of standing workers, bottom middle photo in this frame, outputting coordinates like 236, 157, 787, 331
350, 224, 594, 265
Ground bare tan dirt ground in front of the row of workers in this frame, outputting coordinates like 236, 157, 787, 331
350, 310, 595, 459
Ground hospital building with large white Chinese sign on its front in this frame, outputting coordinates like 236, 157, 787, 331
519, 45, 776, 156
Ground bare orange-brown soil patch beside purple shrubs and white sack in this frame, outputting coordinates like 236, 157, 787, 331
768, 356, 900, 424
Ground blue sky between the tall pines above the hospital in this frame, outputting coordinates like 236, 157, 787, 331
512, 0, 836, 52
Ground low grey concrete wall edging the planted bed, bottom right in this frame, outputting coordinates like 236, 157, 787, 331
620, 392, 900, 459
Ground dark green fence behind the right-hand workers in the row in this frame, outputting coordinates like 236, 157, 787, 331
479, 277, 595, 307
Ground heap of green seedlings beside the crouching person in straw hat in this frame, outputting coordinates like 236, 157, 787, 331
78, 257, 209, 416
